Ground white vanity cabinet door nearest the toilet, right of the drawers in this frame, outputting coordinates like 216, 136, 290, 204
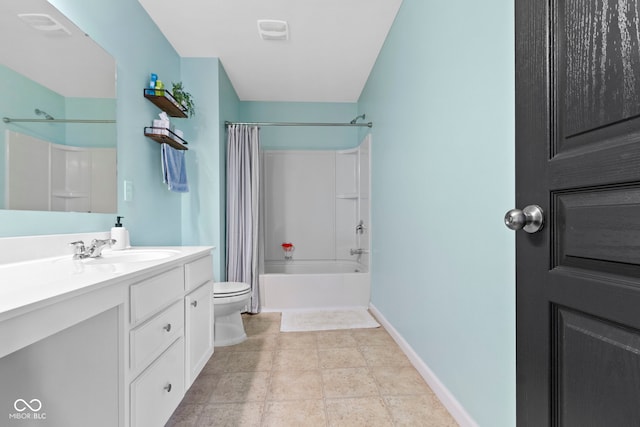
185, 282, 213, 388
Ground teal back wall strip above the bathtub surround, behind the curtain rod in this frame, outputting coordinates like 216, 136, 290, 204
240, 101, 360, 150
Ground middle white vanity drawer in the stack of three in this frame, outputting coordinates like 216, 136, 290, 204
130, 301, 184, 371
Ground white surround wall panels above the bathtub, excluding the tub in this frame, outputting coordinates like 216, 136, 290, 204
263, 136, 371, 266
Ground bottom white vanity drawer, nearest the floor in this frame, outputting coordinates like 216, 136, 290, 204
131, 337, 184, 427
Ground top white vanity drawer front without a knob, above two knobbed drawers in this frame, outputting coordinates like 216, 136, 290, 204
131, 267, 184, 323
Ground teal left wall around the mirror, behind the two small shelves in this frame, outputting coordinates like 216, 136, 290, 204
0, 0, 182, 245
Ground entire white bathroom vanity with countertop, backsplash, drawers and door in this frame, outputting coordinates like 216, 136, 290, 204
0, 233, 214, 427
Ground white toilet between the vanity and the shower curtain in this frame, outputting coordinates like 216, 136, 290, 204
213, 282, 251, 347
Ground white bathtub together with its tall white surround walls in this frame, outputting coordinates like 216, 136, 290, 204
260, 135, 371, 311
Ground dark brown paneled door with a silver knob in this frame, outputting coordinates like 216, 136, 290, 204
515, 0, 640, 427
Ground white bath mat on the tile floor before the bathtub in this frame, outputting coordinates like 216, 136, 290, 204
280, 308, 380, 332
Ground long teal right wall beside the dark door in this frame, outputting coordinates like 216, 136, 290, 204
359, 0, 515, 427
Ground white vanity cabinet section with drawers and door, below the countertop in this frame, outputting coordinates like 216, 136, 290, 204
129, 255, 213, 427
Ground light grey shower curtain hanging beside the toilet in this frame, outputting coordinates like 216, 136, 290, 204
227, 125, 262, 313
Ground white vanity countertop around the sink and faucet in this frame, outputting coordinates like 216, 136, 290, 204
0, 246, 214, 320
